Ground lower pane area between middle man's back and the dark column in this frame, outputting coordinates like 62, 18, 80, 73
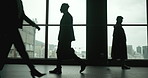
72, 26, 86, 59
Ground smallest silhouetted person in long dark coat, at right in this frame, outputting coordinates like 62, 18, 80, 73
111, 16, 130, 69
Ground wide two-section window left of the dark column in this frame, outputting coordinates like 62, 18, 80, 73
9, 0, 86, 59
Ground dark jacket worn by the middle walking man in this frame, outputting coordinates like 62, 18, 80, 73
58, 12, 75, 42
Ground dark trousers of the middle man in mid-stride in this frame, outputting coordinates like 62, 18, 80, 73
57, 41, 82, 68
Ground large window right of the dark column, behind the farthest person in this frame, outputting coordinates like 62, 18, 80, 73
107, 0, 148, 59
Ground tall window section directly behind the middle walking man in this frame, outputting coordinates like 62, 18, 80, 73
48, 0, 86, 58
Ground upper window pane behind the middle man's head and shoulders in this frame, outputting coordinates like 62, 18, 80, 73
49, 0, 86, 24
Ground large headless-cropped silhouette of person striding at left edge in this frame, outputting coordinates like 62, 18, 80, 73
0, 0, 45, 78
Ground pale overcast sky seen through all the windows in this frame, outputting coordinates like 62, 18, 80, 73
22, 0, 147, 50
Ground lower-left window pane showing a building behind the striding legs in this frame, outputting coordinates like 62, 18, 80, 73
8, 26, 45, 58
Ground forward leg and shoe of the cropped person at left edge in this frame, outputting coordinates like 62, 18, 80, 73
14, 31, 45, 78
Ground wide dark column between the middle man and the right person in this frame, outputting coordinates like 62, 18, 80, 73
87, 0, 107, 65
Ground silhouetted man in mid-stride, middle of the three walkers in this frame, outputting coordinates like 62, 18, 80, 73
49, 3, 86, 74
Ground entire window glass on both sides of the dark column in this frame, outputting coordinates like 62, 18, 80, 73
9, 0, 148, 59
